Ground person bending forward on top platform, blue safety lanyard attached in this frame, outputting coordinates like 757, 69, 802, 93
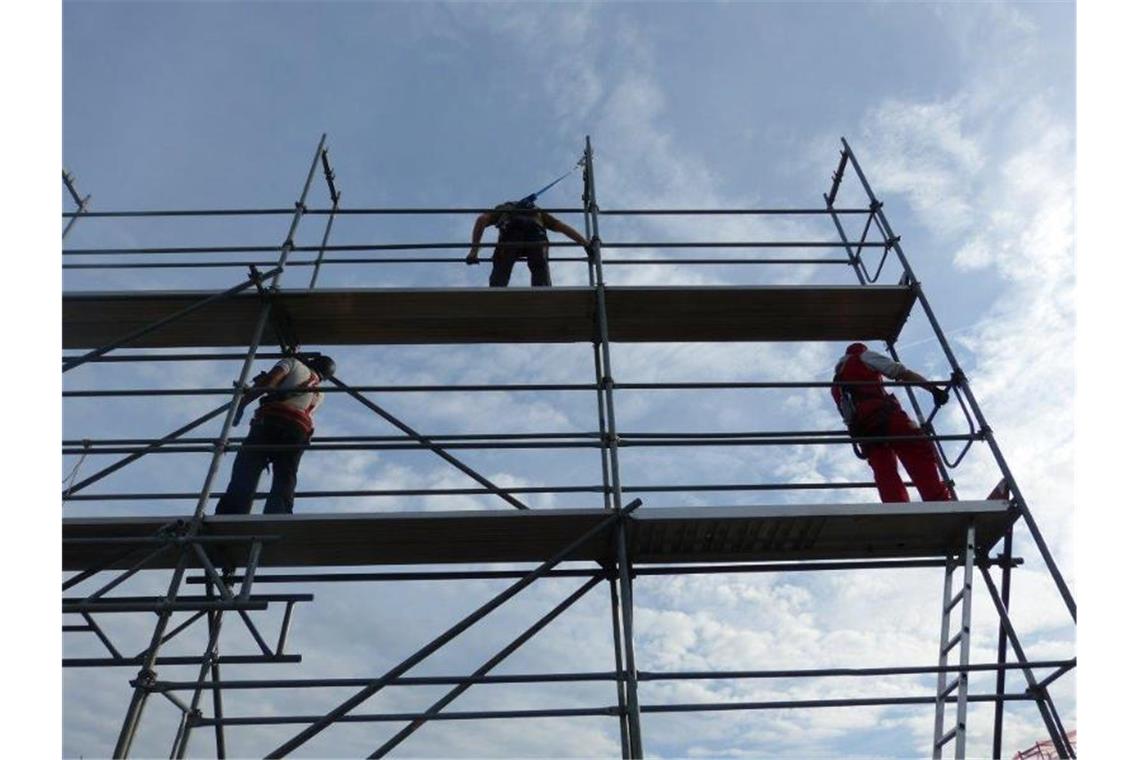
466, 201, 591, 287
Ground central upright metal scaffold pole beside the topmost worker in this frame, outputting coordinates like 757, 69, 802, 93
586, 136, 642, 758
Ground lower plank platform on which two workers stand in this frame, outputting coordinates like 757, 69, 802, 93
63, 501, 1011, 571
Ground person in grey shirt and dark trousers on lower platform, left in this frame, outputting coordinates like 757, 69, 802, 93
214, 353, 336, 515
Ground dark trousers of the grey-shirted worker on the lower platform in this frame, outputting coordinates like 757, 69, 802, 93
214, 415, 310, 515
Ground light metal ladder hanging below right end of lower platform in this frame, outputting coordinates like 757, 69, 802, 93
931, 521, 975, 760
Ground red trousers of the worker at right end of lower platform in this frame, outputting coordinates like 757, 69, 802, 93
861, 407, 953, 501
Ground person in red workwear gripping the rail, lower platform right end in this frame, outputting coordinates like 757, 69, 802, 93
831, 343, 953, 501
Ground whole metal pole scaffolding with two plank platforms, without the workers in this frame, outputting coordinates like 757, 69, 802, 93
62, 136, 1076, 758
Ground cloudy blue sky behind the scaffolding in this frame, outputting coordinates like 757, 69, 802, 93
33, 1, 1103, 758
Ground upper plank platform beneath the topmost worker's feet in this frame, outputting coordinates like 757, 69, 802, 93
63, 285, 915, 349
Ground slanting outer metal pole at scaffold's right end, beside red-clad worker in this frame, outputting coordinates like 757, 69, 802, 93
842, 138, 1076, 622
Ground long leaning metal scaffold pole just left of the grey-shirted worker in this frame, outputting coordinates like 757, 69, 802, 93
114, 134, 326, 758
